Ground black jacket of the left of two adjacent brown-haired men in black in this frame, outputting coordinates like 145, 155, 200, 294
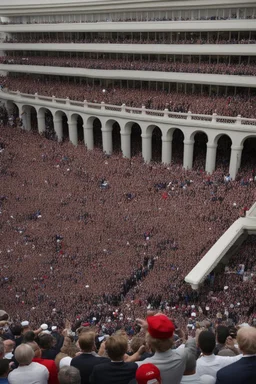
70, 353, 110, 384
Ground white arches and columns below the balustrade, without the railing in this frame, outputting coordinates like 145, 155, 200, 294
7, 101, 256, 178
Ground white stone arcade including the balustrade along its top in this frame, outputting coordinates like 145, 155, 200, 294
0, 91, 256, 179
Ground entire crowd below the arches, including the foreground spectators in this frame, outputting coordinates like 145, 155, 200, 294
0, 118, 256, 384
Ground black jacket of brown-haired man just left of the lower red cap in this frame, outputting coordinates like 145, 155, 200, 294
90, 361, 138, 384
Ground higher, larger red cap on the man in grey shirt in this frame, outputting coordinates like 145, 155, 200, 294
147, 315, 175, 339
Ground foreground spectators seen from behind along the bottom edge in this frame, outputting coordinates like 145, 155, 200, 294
0, 310, 256, 384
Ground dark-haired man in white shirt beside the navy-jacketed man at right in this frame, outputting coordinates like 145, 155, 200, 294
196, 331, 243, 379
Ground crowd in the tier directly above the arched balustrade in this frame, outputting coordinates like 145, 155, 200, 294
1, 75, 256, 118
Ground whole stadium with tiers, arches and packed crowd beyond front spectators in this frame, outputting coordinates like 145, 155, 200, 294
0, 0, 256, 384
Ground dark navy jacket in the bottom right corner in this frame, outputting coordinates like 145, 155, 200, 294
216, 356, 256, 384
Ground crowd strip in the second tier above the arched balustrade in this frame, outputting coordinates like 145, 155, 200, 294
0, 56, 256, 76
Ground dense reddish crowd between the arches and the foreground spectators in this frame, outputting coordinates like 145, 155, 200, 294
0, 112, 255, 332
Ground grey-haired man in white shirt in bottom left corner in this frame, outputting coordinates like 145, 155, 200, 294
8, 344, 49, 384
